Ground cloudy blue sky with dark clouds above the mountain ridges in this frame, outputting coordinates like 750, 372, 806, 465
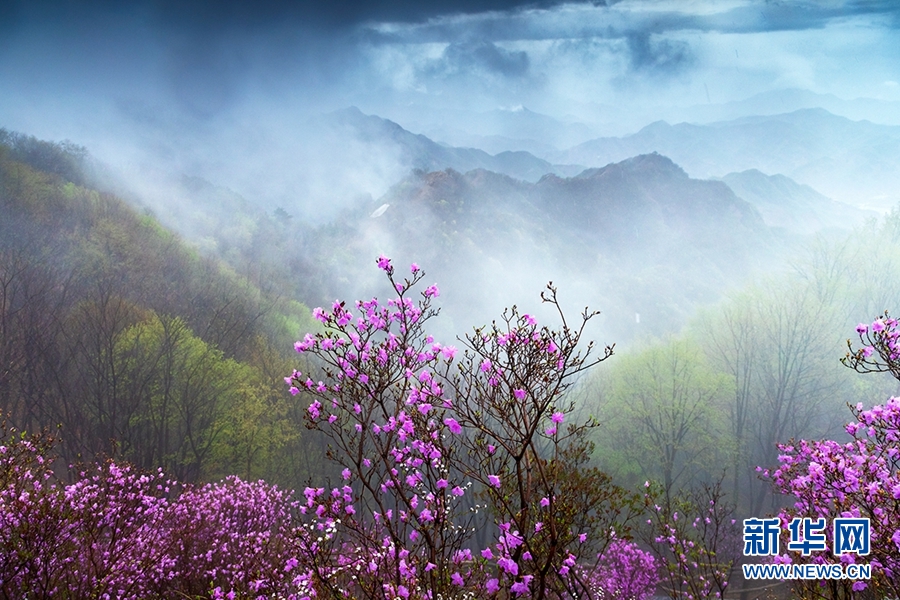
0, 0, 900, 214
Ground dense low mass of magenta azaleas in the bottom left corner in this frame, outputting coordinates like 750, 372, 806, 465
0, 420, 302, 598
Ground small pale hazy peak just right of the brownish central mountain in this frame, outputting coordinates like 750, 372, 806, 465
722, 169, 877, 234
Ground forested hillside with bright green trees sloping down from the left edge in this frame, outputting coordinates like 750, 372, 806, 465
0, 132, 322, 485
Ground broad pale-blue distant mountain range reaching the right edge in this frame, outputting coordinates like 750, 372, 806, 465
550, 109, 900, 209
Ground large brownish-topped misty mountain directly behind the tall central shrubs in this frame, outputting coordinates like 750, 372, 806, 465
318, 154, 786, 342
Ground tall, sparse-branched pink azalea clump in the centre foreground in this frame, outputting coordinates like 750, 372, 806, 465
285, 256, 653, 598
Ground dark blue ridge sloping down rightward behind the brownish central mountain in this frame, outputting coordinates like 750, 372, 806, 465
322, 107, 584, 181
